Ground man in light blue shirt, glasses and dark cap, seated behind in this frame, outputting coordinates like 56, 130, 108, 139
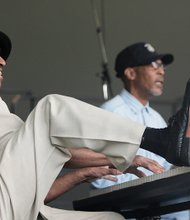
92, 42, 189, 220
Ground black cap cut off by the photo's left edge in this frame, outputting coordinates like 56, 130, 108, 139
0, 31, 12, 60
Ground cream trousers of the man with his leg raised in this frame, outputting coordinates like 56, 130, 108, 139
0, 95, 145, 220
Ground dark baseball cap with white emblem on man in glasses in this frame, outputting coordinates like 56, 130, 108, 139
115, 42, 174, 77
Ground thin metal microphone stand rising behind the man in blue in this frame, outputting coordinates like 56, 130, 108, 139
91, 0, 113, 100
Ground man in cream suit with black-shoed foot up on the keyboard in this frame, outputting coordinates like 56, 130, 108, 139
0, 32, 190, 220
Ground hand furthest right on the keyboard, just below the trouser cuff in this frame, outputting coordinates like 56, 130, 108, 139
124, 155, 165, 177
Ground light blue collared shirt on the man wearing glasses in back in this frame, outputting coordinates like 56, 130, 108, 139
92, 89, 189, 220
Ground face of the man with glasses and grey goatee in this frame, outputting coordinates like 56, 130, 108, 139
133, 60, 165, 97
